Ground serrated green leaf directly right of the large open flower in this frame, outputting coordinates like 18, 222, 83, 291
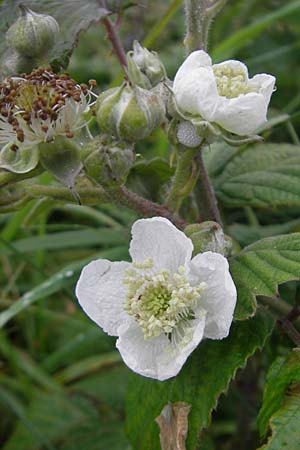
230, 233, 300, 320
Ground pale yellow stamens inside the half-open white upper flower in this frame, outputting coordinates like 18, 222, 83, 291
213, 64, 257, 98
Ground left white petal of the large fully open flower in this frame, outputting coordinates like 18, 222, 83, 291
76, 259, 132, 336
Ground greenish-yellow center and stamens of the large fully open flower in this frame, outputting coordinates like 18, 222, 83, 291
123, 259, 206, 339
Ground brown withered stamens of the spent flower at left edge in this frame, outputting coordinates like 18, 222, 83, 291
0, 68, 94, 150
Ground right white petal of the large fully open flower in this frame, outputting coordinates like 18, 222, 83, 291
190, 252, 236, 339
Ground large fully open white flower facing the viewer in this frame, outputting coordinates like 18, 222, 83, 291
76, 217, 236, 380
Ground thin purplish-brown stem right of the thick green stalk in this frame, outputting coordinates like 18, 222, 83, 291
195, 151, 222, 226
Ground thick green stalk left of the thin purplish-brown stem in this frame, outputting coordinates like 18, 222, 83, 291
165, 146, 199, 212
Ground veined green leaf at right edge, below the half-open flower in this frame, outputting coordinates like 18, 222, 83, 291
208, 144, 300, 208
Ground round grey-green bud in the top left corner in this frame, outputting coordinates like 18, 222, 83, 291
6, 5, 59, 57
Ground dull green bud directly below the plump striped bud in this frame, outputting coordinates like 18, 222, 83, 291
82, 136, 135, 187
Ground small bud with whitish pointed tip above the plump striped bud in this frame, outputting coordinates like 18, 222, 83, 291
127, 41, 166, 89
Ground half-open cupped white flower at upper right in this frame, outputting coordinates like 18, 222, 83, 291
173, 50, 275, 136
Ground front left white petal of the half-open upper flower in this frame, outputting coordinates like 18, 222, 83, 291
173, 67, 219, 121
